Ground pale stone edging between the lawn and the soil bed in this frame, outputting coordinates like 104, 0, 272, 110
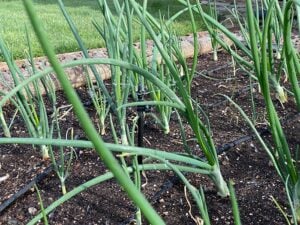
0, 31, 232, 94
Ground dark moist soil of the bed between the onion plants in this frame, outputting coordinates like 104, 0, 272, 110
0, 52, 300, 225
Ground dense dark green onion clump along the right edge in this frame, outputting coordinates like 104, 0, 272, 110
178, 0, 300, 224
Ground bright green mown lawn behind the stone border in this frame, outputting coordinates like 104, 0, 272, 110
0, 0, 202, 60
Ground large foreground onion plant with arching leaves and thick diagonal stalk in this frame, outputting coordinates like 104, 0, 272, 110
0, 0, 237, 224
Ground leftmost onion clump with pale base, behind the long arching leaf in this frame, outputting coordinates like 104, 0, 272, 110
0, 33, 56, 159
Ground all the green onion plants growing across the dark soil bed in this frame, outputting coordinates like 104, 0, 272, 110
0, 0, 300, 224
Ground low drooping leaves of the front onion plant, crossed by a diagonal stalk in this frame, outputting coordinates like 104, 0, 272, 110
0, 135, 230, 224
